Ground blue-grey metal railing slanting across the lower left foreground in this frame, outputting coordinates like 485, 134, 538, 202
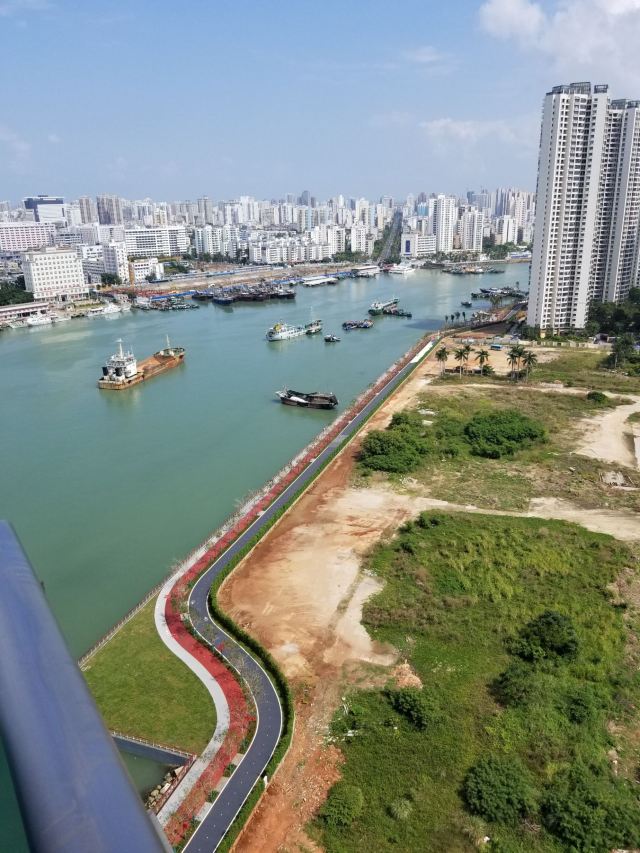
0, 521, 170, 853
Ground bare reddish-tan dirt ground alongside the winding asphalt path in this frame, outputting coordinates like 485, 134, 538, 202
220, 342, 640, 853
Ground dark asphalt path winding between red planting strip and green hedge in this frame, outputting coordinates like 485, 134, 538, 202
184, 342, 430, 853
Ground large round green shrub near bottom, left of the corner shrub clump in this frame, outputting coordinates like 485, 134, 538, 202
463, 756, 535, 824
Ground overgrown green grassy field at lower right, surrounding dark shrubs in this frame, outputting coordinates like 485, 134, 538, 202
311, 513, 640, 853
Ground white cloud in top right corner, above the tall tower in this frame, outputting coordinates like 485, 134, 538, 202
479, 0, 640, 91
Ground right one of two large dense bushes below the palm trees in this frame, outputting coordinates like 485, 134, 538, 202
464, 409, 545, 459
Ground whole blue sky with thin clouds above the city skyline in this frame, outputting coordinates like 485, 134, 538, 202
0, 0, 640, 200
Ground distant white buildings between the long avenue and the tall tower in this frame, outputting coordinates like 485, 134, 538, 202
401, 188, 535, 258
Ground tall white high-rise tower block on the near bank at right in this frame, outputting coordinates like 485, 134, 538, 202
527, 83, 640, 329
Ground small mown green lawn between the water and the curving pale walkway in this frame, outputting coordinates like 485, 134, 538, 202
84, 601, 216, 753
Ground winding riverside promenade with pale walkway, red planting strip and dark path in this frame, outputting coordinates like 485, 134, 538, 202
156, 337, 438, 853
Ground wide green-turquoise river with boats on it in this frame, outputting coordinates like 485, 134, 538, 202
0, 264, 528, 853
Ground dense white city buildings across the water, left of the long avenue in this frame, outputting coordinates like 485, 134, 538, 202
0, 190, 395, 301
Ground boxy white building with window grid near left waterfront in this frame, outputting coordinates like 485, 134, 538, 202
22, 247, 89, 302
